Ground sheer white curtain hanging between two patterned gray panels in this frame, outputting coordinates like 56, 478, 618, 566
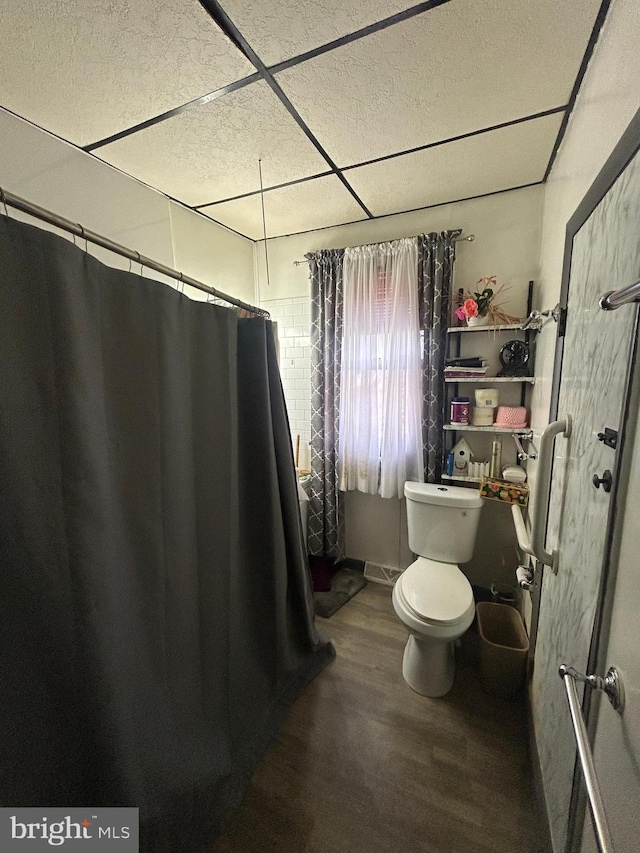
338, 238, 424, 498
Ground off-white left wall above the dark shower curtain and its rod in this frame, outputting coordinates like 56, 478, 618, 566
0, 109, 255, 303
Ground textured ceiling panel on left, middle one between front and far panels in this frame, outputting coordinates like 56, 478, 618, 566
101, 82, 327, 205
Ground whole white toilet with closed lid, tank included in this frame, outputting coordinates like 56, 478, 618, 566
393, 482, 482, 696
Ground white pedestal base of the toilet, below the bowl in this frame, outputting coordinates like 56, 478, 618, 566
402, 634, 456, 698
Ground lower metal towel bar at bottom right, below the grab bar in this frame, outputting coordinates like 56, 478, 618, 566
559, 664, 623, 853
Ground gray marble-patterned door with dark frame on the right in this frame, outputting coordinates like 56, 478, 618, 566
531, 150, 640, 853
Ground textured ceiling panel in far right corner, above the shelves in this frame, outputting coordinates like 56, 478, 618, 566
344, 115, 562, 216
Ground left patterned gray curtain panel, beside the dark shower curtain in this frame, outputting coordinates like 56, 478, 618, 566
306, 249, 344, 560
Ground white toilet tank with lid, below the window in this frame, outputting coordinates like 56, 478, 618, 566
404, 482, 482, 563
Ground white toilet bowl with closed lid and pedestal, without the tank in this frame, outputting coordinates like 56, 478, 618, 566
393, 557, 475, 697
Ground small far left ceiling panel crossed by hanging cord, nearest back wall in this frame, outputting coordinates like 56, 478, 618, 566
201, 175, 366, 240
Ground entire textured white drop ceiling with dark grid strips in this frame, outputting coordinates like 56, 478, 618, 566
0, 0, 606, 239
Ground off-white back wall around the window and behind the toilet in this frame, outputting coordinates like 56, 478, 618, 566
256, 186, 543, 586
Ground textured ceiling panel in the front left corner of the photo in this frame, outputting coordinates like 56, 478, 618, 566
0, 0, 255, 145
